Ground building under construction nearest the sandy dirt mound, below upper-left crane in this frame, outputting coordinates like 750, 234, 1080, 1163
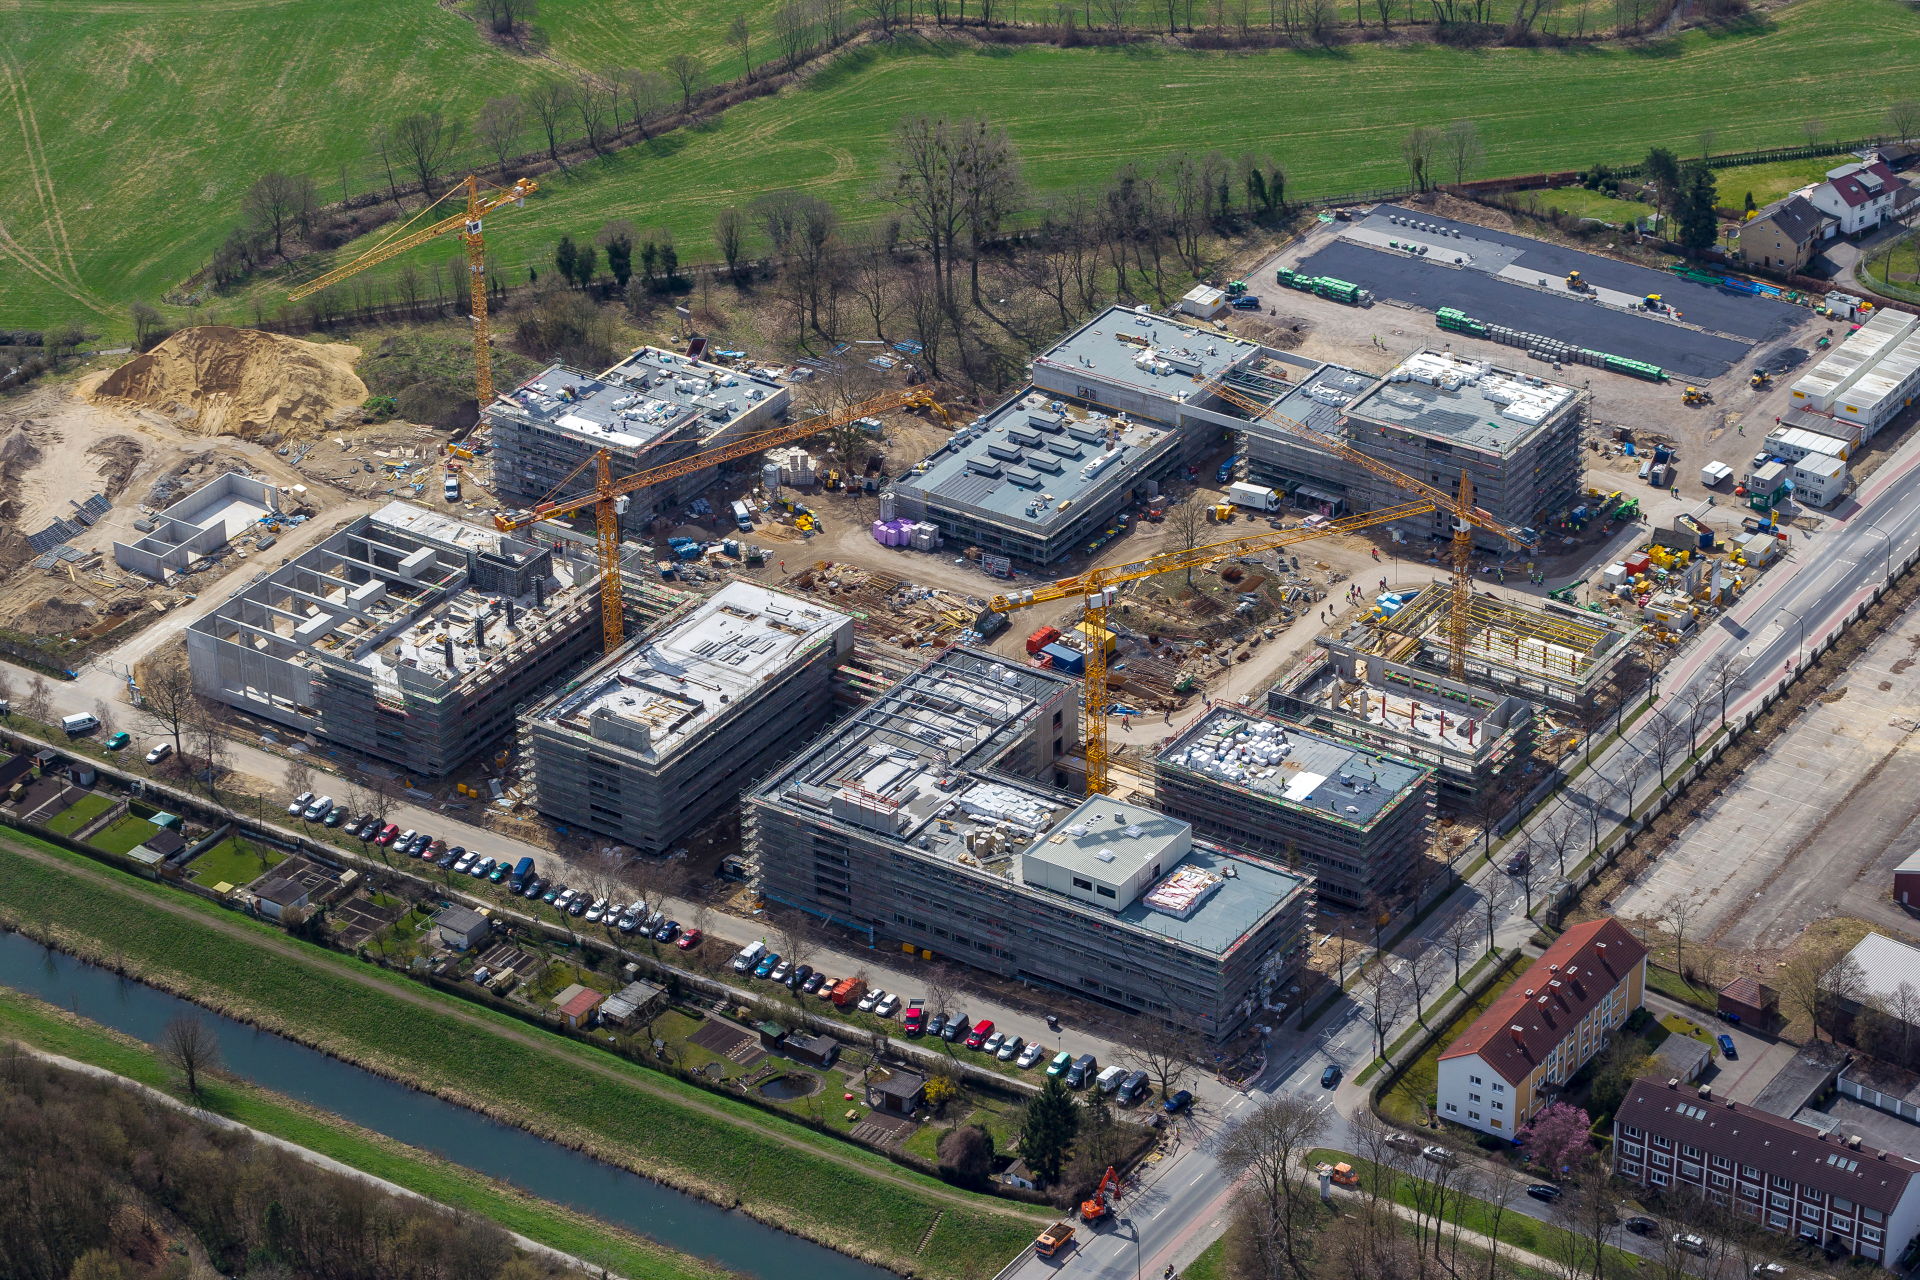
484, 347, 791, 514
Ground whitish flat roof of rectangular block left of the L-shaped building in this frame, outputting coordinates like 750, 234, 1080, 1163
528, 581, 852, 758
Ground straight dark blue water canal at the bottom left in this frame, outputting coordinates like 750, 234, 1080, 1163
0, 931, 893, 1280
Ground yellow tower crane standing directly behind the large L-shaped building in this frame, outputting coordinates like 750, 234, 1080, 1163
987, 499, 1436, 794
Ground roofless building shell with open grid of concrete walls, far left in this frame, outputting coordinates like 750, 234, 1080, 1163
186, 503, 601, 777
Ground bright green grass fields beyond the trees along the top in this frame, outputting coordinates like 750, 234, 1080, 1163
11, 0, 1920, 328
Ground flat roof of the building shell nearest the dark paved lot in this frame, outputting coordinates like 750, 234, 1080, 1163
1350, 349, 1578, 457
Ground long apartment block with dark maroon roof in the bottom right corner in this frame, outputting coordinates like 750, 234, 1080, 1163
1613, 1080, 1920, 1263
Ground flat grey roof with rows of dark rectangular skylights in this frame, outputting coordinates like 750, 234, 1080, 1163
895, 388, 1175, 533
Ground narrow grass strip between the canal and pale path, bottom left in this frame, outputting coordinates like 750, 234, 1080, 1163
0, 988, 718, 1280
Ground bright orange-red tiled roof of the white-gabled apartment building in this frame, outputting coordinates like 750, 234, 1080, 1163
1440, 915, 1647, 1084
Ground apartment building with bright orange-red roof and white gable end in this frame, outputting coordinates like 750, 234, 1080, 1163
1436, 915, 1647, 1138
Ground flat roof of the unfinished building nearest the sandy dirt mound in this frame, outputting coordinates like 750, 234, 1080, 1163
495, 347, 787, 451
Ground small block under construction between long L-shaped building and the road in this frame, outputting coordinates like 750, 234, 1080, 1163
1154, 706, 1432, 906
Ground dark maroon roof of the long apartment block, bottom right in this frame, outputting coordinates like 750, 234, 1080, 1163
1613, 1080, 1920, 1213
